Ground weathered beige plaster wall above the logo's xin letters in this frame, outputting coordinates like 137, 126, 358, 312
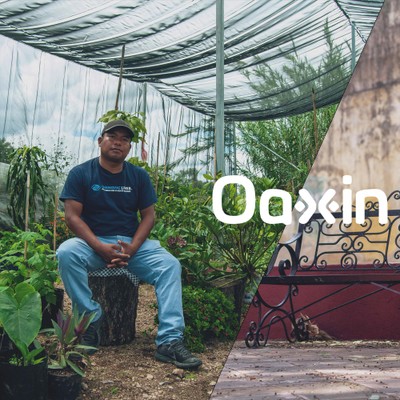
305, 0, 400, 197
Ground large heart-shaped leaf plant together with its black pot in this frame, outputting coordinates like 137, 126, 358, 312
0, 282, 47, 400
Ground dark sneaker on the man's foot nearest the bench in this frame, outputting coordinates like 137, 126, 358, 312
155, 340, 202, 369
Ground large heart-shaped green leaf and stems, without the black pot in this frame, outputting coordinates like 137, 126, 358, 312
0, 282, 44, 366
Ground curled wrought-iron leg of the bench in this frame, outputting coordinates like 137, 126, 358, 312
245, 285, 305, 347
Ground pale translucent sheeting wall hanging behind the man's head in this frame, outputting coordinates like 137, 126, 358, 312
0, 37, 206, 172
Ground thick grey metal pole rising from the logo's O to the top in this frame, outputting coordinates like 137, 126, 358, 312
215, 0, 225, 175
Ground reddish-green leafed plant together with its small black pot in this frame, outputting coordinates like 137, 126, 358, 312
42, 308, 95, 400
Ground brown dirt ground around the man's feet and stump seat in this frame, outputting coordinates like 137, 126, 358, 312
80, 285, 233, 400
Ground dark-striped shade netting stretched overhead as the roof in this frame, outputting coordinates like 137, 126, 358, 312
0, 0, 383, 123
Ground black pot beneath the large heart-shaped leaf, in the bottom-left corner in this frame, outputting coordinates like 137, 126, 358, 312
0, 355, 48, 400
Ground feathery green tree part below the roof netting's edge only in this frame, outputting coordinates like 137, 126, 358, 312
239, 105, 337, 192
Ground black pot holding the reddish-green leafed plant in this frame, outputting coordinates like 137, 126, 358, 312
48, 369, 82, 400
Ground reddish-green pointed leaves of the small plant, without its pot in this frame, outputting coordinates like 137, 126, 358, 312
42, 308, 95, 376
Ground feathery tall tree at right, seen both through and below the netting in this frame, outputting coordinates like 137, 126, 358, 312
238, 21, 349, 192
